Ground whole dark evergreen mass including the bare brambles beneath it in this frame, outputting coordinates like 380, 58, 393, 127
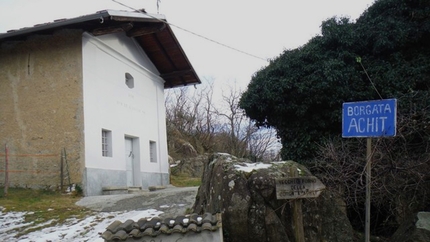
240, 0, 430, 236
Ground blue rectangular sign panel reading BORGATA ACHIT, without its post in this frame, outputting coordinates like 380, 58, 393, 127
342, 99, 397, 138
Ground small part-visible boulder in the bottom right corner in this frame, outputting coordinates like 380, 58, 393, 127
390, 212, 430, 242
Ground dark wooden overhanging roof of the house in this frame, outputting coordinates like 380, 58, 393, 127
0, 10, 201, 88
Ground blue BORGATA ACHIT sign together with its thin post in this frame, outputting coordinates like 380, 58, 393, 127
342, 99, 397, 242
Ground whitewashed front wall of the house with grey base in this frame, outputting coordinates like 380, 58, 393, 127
82, 33, 169, 195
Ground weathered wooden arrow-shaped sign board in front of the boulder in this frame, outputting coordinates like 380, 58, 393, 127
276, 176, 325, 199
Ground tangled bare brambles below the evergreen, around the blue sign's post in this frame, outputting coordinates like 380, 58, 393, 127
309, 93, 430, 233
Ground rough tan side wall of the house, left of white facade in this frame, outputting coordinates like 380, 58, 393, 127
0, 31, 84, 188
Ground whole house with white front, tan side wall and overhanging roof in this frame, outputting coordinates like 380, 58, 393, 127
0, 10, 200, 196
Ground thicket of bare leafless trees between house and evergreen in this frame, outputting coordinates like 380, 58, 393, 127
165, 81, 276, 160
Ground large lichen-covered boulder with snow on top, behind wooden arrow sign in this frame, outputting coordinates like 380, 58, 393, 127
193, 153, 353, 242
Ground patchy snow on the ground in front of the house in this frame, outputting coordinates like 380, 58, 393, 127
0, 207, 163, 242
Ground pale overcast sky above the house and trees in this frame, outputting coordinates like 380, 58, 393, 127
0, 0, 374, 93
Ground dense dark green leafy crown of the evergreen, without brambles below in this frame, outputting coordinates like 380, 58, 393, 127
240, 0, 430, 162
